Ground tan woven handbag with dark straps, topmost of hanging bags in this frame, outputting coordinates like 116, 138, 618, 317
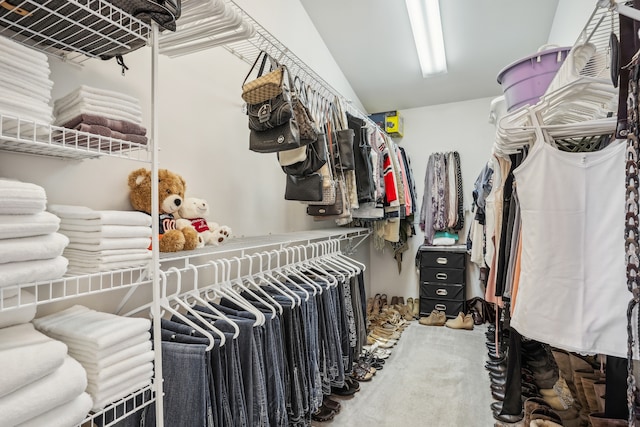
242, 51, 285, 104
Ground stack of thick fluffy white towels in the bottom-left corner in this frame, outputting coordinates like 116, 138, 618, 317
0, 323, 92, 427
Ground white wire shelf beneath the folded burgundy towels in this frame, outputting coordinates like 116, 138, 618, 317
0, 113, 151, 162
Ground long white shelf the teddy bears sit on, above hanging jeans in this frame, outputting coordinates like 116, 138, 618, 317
160, 227, 371, 266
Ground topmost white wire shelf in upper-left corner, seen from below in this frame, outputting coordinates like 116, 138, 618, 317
0, 0, 151, 63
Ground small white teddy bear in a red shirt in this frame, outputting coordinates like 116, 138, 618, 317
176, 197, 231, 246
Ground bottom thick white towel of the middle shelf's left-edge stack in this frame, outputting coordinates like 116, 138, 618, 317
0, 256, 68, 288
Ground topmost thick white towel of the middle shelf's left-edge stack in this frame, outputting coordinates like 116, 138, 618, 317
0, 178, 47, 215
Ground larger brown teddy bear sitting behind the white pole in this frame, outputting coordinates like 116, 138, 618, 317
129, 168, 200, 252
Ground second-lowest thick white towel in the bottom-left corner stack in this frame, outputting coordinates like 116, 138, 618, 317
0, 357, 87, 426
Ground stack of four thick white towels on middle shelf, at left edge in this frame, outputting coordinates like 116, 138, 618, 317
0, 178, 69, 288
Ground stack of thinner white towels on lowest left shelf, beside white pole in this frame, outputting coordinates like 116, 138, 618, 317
33, 305, 154, 410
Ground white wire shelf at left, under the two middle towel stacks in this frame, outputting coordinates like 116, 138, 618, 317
0, 266, 152, 312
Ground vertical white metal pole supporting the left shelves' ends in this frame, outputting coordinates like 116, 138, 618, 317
150, 21, 164, 427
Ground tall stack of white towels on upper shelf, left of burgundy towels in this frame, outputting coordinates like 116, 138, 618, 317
0, 36, 53, 126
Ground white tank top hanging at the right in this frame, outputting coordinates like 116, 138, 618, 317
511, 129, 631, 358
